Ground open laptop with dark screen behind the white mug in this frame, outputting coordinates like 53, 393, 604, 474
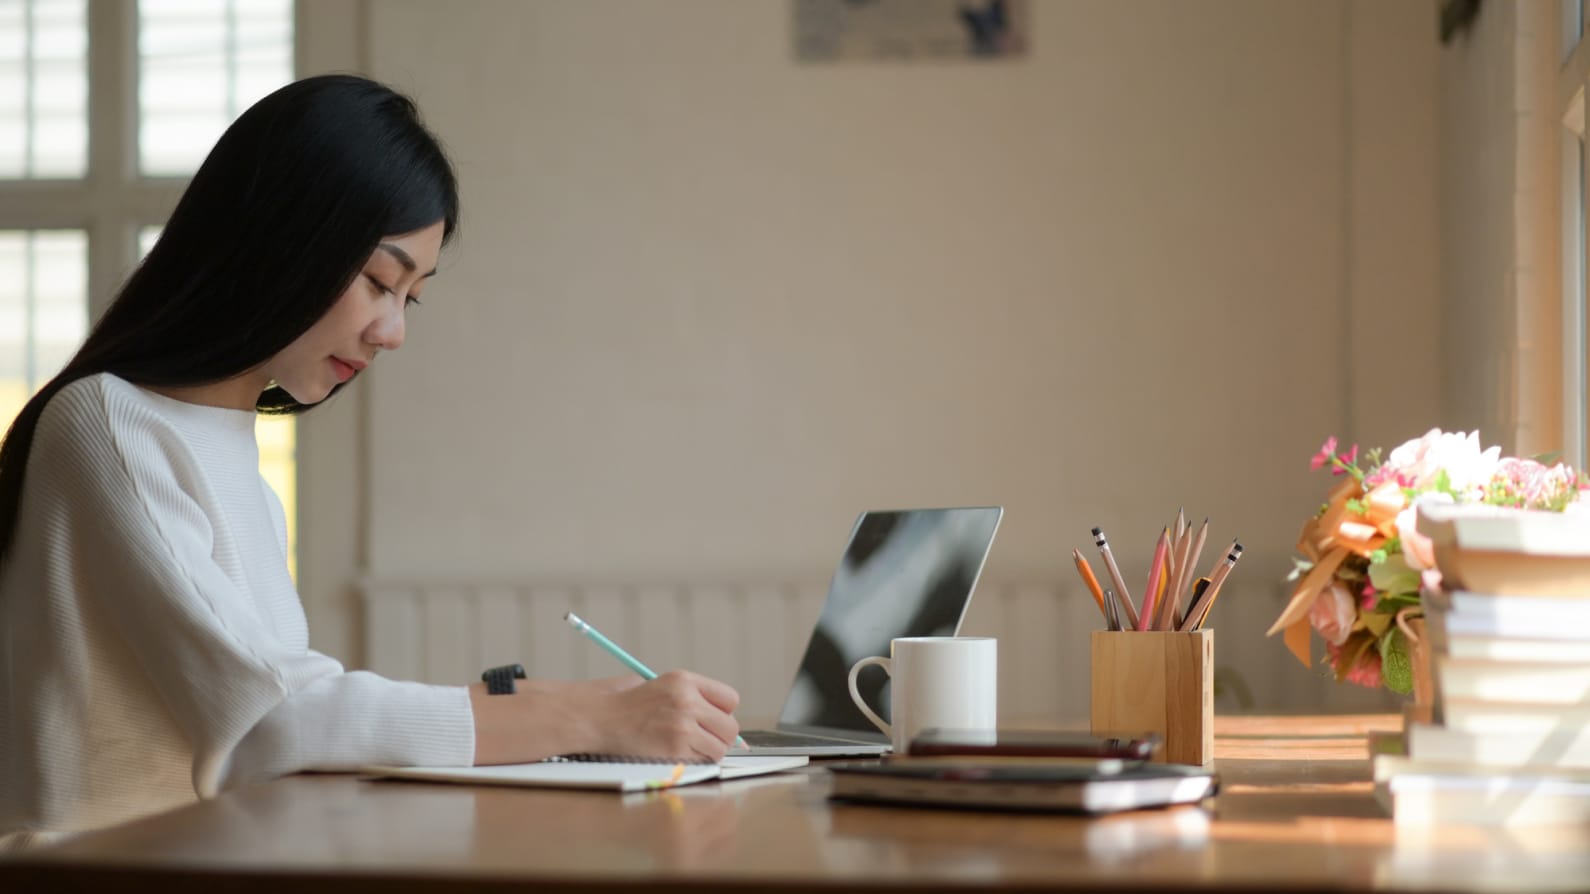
731, 506, 1005, 757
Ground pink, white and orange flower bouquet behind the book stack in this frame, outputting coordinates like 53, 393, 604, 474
1269, 428, 1590, 694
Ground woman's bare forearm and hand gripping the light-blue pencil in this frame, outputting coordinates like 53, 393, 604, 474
469, 671, 739, 764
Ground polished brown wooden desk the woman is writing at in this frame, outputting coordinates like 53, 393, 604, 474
0, 716, 1590, 894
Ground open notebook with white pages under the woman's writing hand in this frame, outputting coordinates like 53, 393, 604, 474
363, 754, 806, 792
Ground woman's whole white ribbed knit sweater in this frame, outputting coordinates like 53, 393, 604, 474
0, 374, 474, 849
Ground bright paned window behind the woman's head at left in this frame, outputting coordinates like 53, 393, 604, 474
0, 0, 297, 562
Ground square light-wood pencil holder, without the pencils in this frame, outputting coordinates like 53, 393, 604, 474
1089, 630, 1215, 765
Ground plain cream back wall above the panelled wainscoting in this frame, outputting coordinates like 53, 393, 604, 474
292, 0, 1444, 706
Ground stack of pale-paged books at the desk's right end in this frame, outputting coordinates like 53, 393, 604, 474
1374, 506, 1590, 826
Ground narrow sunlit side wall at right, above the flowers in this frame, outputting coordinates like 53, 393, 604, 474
1441, 0, 1563, 455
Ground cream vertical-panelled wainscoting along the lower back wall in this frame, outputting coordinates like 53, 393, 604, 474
363, 581, 1323, 725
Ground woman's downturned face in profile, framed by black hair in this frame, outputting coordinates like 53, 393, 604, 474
261, 221, 442, 404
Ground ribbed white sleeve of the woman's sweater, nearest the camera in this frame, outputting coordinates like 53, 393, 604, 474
29, 375, 474, 797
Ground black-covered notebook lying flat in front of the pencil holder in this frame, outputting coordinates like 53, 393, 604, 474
828, 759, 1220, 813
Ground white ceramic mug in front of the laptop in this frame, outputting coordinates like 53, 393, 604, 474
851, 636, 999, 754
